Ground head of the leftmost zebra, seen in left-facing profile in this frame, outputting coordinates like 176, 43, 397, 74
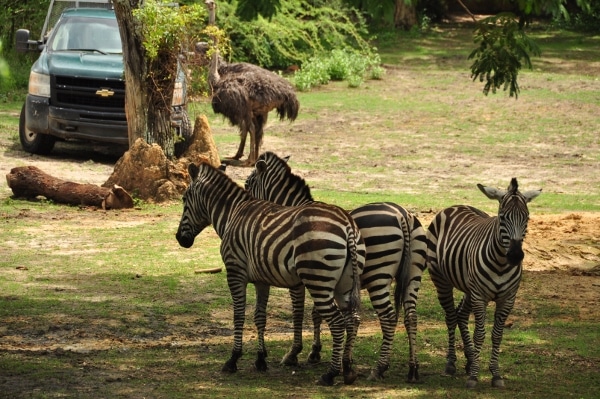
175, 163, 210, 248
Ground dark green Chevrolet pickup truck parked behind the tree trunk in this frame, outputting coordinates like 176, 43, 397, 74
16, 0, 191, 156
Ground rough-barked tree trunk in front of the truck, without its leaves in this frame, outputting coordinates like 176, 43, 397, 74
113, 0, 177, 159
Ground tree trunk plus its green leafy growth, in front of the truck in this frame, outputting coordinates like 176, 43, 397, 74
113, 0, 206, 158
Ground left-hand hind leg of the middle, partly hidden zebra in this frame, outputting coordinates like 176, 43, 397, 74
368, 285, 398, 380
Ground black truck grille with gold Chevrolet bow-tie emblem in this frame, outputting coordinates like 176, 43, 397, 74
51, 76, 125, 112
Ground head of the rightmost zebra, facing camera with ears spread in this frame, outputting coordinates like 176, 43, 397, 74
477, 177, 542, 265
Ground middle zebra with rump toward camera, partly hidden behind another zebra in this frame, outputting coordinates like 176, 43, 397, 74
246, 152, 427, 382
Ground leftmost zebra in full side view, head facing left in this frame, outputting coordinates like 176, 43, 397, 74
176, 163, 365, 385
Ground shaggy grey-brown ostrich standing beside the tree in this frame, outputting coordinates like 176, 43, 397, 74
196, 0, 300, 166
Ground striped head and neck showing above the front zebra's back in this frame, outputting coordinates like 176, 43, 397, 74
245, 152, 313, 206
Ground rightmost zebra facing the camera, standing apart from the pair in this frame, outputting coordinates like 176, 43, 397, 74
427, 178, 542, 388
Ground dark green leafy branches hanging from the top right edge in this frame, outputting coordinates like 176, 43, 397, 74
338, 0, 600, 98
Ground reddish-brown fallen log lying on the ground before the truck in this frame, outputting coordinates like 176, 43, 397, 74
6, 166, 133, 209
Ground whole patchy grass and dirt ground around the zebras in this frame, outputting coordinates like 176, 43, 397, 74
0, 24, 600, 399
